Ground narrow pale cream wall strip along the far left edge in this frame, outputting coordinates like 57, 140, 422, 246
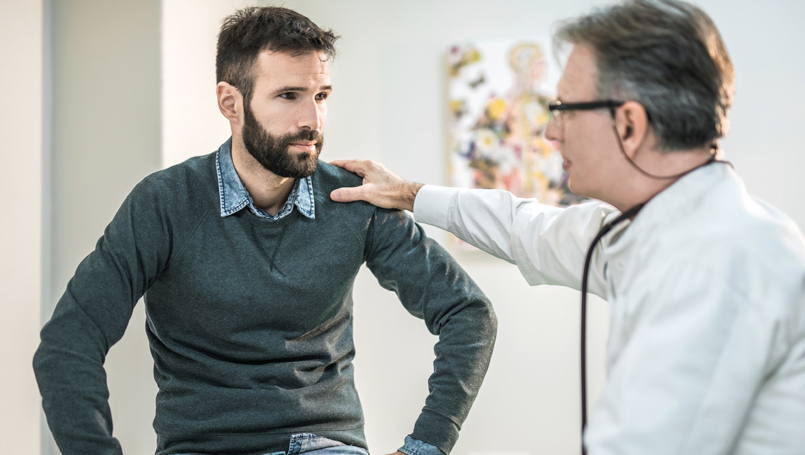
0, 0, 42, 453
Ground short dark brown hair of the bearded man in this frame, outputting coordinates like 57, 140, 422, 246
215, 6, 339, 104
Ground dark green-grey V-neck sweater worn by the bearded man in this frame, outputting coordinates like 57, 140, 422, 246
34, 153, 496, 455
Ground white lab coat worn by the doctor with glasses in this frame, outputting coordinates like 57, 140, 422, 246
414, 163, 805, 455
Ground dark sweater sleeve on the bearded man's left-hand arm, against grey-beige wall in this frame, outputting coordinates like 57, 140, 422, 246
34, 181, 170, 455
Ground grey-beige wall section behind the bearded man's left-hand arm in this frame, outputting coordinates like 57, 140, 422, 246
46, 0, 161, 454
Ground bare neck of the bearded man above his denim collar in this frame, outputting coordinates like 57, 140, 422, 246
232, 138, 296, 216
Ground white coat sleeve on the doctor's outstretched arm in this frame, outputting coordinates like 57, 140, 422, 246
414, 185, 616, 296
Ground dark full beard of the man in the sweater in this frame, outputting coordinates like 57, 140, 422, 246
242, 101, 324, 179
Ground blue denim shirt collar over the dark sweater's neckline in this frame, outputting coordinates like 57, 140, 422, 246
215, 137, 316, 220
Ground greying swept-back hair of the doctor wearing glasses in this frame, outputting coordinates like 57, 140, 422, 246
554, 0, 735, 151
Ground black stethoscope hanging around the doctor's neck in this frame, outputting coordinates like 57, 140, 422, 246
580, 129, 732, 455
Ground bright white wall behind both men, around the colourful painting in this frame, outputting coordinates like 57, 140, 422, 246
163, 0, 805, 454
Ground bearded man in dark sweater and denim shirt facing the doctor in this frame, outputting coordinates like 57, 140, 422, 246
34, 7, 496, 455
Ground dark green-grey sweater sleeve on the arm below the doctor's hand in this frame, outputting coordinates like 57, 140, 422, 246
366, 209, 497, 453
